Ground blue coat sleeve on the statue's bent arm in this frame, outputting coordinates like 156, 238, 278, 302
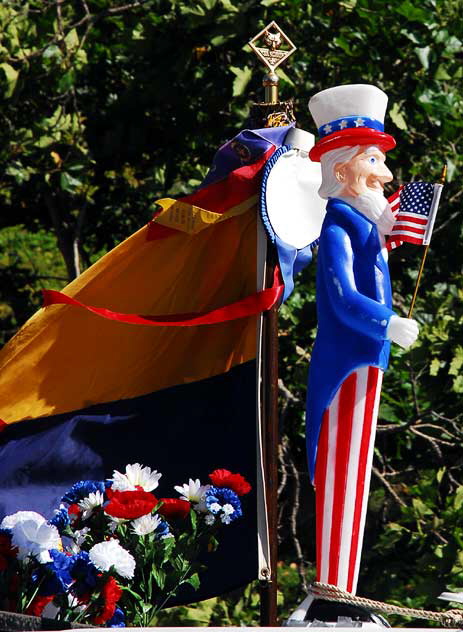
323, 226, 394, 340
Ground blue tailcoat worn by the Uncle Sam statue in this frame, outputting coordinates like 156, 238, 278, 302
307, 198, 394, 480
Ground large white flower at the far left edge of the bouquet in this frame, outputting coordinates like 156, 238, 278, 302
0, 511, 62, 564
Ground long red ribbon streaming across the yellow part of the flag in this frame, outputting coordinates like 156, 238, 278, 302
42, 266, 284, 327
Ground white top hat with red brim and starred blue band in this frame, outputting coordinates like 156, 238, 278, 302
309, 84, 396, 162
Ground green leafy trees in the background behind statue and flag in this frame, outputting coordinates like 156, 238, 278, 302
0, 0, 463, 624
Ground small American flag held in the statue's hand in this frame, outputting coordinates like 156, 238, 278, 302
386, 182, 442, 250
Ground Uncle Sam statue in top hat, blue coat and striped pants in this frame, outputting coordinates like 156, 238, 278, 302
307, 85, 418, 593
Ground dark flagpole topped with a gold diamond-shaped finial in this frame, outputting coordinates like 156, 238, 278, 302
249, 22, 296, 626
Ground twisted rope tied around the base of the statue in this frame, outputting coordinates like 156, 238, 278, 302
311, 582, 463, 628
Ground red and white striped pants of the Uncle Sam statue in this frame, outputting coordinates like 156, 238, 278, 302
315, 367, 383, 593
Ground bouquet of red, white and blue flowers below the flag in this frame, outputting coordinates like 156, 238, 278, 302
0, 463, 251, 627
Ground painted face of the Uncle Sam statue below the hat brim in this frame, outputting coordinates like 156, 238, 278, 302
335, 147, 392, 196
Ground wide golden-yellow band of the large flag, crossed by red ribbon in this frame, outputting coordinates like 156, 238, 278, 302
0, 207, 257, 423
